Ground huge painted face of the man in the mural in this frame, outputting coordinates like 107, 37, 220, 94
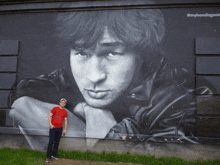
70, 28, 143, 108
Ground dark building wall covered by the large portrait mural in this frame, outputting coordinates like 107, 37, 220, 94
0, 1, 220, 158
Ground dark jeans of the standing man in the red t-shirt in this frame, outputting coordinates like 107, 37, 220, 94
47, 127, 63, 157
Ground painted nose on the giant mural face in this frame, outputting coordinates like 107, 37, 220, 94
88, 56, 106, 83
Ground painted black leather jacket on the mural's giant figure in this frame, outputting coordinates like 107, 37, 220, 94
9, 60, 211, 143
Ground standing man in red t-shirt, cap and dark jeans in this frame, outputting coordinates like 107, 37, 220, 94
46, 98, 67, 163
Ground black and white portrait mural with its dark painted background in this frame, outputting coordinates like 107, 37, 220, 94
2, 1, 220, 149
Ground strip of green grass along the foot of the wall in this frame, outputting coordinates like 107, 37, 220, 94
0, 148, 220, 165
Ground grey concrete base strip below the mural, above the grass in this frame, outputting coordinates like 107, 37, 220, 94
0, 134, 220, 161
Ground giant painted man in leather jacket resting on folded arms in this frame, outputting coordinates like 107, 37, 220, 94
10, 1, 205, 148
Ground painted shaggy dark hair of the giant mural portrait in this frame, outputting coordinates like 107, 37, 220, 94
57, 1, 165, 77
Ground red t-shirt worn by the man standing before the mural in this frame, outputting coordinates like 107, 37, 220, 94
51, 107, 67, 128
